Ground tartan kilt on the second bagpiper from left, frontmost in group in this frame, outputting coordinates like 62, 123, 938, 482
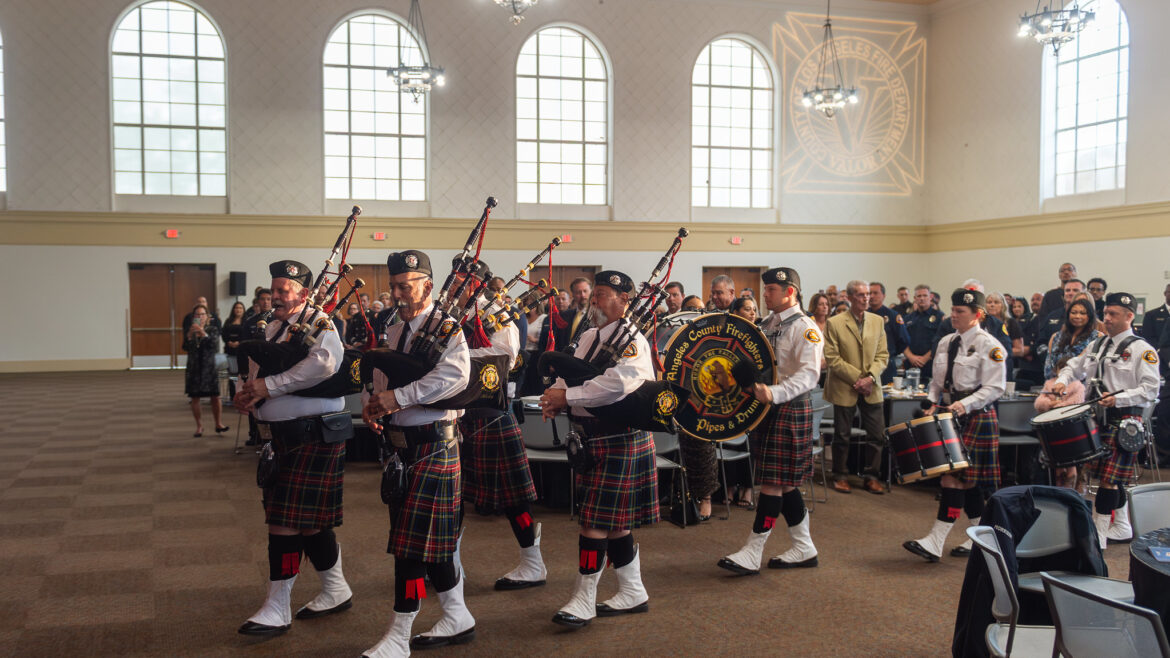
386, 441, 462, 562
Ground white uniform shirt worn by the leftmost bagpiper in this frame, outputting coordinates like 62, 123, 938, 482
252, 311, 345, 423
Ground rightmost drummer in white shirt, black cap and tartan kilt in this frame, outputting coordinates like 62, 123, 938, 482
1052, 293, 1159, 548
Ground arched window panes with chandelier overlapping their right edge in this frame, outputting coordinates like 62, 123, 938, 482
324, 14, 427, 201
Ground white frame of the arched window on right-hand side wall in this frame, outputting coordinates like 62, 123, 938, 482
1040, 0, 1131, 212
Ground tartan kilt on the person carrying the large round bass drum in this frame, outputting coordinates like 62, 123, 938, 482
749, 398, 813, 487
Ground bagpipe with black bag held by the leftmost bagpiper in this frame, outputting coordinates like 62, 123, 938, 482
236, 206, 373, 398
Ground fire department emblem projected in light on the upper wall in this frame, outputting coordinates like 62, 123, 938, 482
772, 13, 925, 196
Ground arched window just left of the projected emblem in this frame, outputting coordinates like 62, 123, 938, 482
690, 37, 773, 208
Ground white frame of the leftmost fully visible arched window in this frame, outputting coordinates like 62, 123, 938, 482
106, 0, 232, 213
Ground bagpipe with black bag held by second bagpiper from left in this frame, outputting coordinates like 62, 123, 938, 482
359, 197, 508, 409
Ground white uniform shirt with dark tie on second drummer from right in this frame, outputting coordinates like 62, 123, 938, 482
929, 324, 1007, 413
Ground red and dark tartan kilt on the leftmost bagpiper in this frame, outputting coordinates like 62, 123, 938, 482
262, 439, 345, 530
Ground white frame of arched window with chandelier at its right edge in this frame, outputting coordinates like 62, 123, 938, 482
317, 8, 430, 217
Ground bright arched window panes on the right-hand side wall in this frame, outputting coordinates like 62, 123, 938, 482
1044, 0, 1129, 198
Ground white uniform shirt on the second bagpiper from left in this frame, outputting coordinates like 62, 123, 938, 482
372, 304, 472, 427
